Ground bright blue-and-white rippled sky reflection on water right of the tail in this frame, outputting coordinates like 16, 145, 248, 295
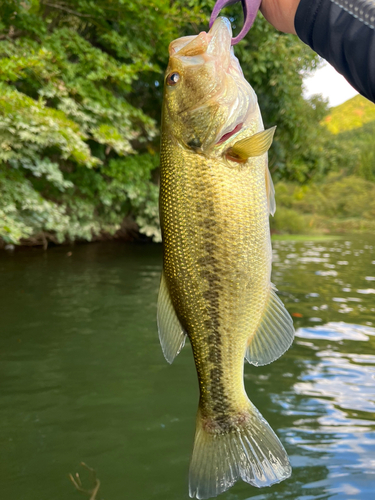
288, 323, 375, 498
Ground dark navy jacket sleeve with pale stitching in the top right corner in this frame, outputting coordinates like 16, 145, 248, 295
294, 0, 375, 102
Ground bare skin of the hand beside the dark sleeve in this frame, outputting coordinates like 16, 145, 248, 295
260, 0, 300, 35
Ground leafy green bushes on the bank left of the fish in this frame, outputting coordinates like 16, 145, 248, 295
0, 0, 177, 243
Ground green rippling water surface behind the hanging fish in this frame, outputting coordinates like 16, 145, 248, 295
0, 236, 375, 500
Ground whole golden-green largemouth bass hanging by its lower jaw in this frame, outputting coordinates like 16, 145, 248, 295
157, 17, 294, 499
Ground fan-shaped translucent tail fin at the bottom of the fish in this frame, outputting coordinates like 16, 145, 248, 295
189, 401, 292, 499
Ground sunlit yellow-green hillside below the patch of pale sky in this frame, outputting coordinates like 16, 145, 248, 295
323, 95, 375, 134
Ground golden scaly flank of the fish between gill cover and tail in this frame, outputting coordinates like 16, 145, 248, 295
160, 134, 270, 418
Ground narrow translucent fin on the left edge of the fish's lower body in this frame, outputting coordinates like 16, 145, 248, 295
157, 271, 186, 363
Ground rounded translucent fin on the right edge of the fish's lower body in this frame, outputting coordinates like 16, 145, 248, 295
245, 284, 294, 366
